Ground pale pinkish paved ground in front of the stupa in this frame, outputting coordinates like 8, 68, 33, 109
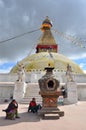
0, 102, 86, 130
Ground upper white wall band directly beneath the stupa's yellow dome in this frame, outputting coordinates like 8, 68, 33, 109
0, 70, 86, 83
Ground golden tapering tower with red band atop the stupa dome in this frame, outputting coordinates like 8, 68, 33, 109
36, 16, 58, 53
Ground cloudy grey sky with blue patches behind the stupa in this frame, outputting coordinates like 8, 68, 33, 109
0, 0, 86, 73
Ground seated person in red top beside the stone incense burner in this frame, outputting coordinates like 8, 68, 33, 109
28, 98, 42, 113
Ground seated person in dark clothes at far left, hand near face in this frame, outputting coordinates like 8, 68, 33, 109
2, 99, 19, 120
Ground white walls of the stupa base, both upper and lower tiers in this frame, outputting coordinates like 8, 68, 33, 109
0, 71, 86, 100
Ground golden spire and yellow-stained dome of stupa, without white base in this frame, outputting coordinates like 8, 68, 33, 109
11, 17, 84, 74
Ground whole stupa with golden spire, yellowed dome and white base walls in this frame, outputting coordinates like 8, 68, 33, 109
0, 17, 86, 103
